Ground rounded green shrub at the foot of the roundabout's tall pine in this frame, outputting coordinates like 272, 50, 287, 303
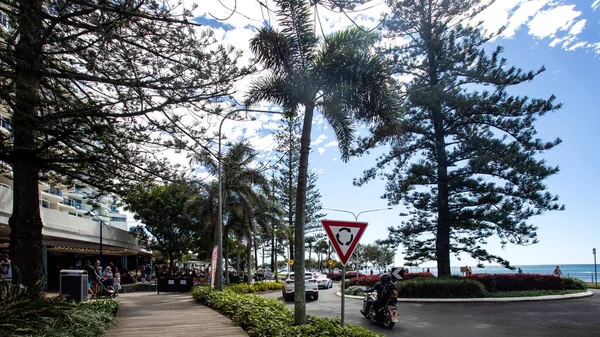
398, 277, 486, 298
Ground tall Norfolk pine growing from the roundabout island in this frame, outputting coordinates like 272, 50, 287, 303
356, 0, 564, 276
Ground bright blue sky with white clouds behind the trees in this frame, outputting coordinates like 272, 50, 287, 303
152, 0, 600, 267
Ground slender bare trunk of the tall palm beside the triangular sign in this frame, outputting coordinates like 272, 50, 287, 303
294, 104, 315, 325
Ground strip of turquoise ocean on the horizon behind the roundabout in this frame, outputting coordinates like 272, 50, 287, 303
398, 264, 600, 282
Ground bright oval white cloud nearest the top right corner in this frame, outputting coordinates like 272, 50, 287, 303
528, 5, 581, 39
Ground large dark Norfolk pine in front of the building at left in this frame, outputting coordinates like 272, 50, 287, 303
0, 0, 246, 286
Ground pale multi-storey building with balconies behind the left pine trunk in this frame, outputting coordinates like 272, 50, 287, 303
0, 176, 152, 289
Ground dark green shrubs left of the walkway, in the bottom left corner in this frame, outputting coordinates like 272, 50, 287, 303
0, 281, 119, 337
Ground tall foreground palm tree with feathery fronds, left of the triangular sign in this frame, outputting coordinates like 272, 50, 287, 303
245, 0, 395, 325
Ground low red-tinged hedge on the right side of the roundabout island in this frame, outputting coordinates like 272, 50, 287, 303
465, 274, 586, 292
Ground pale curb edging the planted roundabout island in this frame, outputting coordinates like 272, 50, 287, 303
336, 290, 594, 303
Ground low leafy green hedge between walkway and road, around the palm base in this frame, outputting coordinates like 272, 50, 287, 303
192, 286, 383, 337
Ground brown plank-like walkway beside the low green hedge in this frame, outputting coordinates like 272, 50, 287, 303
105, 292, 248, 337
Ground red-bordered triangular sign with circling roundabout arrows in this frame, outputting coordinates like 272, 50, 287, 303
321, 220, 368, 266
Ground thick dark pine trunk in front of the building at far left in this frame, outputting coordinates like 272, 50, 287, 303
8, 0, 44, 287
